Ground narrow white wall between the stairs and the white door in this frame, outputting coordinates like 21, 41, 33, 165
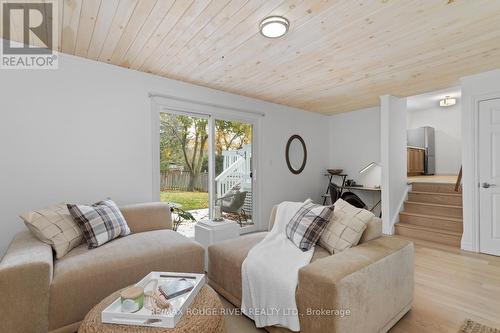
461, 70, 500, 251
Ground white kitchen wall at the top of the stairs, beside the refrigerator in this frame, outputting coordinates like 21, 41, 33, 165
407, 92, 462, 175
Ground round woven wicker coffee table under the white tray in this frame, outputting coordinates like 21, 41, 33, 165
78, 285, 225, 333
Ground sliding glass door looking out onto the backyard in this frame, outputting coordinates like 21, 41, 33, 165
159, 109, 254, 237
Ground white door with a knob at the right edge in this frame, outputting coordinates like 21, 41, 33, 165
478, 99, 500, 255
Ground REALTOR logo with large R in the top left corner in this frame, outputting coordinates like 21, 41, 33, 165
0, 0, 58, 69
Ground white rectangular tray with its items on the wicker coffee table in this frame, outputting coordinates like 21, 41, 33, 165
101, 272, 205, 328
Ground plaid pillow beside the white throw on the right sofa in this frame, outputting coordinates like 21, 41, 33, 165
286, 203, 333, 252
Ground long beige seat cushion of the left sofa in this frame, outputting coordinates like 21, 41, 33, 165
49, 230, 204, 330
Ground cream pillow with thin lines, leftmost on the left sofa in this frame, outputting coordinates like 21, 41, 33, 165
19, 203, 83, 259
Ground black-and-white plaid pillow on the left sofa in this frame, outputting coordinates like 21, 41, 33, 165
68, 199, 130, 249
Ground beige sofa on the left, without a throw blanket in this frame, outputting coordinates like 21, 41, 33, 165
0, 203, 204, 333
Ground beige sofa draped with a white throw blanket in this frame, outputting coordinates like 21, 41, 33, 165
208, 209, 414, 333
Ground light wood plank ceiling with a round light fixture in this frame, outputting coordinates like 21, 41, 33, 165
7, 0, 500, 114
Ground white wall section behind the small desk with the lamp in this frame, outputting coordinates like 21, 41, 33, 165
325, 107, 381, 215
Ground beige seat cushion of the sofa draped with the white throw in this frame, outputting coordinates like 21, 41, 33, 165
208, 232, 330, 306
